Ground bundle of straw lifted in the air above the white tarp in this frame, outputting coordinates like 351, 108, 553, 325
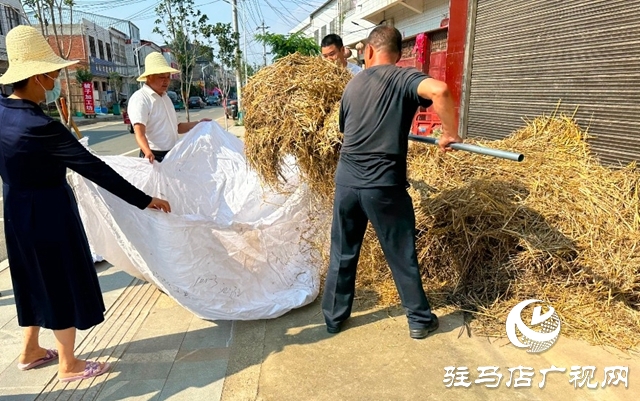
243, 53, 352, 199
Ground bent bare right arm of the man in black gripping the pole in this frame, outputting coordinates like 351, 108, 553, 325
418, 78, 462, 152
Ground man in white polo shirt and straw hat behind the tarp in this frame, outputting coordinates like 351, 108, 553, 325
127, 52, 211, 163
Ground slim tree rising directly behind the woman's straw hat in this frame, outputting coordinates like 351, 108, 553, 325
22, 0, 75, 128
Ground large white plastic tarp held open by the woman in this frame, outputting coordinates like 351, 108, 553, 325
70, 122, 319, 320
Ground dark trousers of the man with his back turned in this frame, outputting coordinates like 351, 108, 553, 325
322, 185, 433, 329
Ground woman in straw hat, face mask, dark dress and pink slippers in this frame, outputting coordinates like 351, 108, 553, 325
0, 25, 170, 381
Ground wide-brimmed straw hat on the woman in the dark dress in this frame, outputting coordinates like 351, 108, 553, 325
0, 25, 78, 85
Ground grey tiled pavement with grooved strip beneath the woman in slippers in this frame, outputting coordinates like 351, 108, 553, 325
0, 262, 233, 401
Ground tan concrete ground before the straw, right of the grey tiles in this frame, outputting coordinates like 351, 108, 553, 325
222, 300, 640, 401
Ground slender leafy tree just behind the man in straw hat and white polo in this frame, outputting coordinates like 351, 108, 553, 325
153, 0, 214, 121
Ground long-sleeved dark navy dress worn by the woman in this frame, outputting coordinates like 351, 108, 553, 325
0, 96, 151, 330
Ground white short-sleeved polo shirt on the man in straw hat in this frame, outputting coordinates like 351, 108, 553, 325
127, 84, 178, 151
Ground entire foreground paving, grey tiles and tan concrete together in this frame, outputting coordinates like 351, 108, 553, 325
0, 262, 640, 401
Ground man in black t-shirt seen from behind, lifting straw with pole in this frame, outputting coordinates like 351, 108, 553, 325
322, 26, 462, 339
